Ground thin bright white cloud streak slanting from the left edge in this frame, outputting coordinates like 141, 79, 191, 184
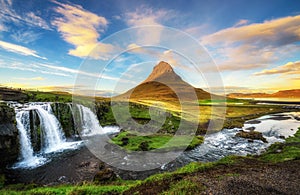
0, 41, 46, 60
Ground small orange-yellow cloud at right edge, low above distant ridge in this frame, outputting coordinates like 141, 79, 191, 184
254, 61, 300, 76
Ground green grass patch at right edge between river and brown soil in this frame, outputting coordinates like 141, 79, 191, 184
259, 128, 300, 163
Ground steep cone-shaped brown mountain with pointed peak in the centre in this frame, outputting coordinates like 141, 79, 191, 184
116, 61, 217, 101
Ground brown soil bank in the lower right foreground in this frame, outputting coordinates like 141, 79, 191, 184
125, 159, 300, 195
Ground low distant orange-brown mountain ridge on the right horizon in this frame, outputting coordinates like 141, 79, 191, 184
227, 89, 300, 98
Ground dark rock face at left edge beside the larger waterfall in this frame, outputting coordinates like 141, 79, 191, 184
0, 103, 19, 172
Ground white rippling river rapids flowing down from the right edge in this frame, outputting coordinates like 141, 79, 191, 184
161, 112, 300, 170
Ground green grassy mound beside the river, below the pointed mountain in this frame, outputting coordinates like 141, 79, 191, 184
112, 131, 204, 151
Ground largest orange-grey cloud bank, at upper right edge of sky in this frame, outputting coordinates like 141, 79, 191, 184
201, 15, 300, 70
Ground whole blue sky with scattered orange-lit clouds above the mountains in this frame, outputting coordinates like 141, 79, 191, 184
0, 0, 300, 96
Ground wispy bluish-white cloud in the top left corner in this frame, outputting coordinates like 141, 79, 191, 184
0, 0, 51, 30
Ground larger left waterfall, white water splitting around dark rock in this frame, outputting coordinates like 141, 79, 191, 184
10, 103, 82, 168
